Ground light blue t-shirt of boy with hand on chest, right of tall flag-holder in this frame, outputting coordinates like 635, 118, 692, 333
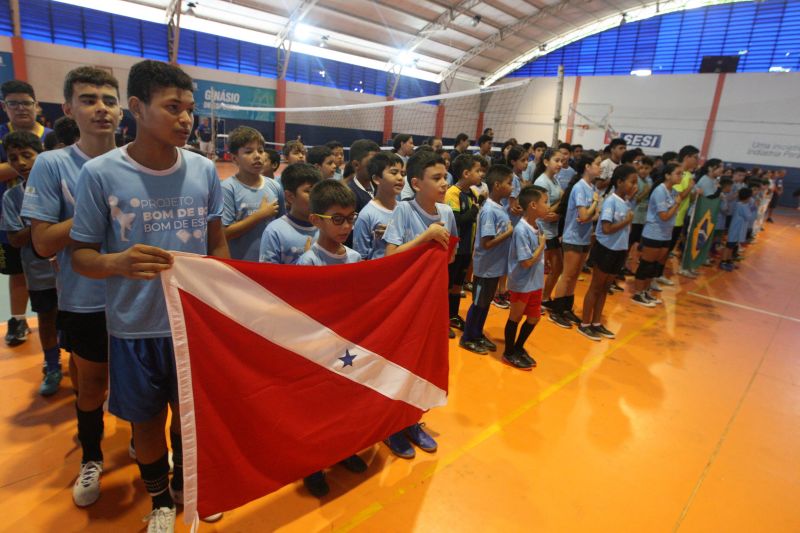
222, 176, 286, 261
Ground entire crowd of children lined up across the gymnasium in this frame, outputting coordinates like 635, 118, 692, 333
0, 61, 778, 531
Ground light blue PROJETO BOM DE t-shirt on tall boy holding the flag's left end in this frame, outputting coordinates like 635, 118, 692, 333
70, 146, 222, 339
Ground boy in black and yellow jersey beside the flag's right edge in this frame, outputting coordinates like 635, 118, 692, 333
445, 154, 481, 339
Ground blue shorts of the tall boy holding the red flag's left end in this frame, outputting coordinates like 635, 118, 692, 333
108, 336, 178, 423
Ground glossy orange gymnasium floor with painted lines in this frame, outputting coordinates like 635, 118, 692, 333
0, 201, 800, 533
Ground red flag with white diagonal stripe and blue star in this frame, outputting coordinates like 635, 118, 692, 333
161, 244, 449, 521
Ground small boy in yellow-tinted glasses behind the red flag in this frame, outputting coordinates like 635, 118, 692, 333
297, 180, 367, 498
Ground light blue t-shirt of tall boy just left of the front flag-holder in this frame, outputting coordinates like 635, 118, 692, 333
22, 144, 106, 313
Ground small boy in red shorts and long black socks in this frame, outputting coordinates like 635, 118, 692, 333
503, 185, 550, 370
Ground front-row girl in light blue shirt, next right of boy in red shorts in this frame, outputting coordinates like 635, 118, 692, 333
550, 156, 600, 329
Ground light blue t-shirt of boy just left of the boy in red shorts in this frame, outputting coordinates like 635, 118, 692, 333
472, 198, 511, 278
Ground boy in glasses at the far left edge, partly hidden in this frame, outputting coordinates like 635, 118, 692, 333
0, 80, 52, 346
